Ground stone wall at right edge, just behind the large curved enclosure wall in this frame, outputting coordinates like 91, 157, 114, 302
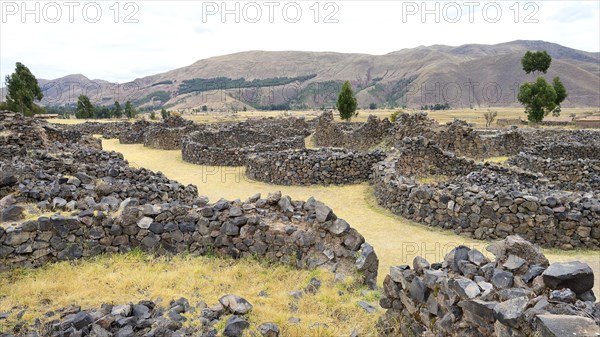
506, 153, 600, 191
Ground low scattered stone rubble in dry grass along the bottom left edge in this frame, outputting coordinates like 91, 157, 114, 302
2, 294, 281, 337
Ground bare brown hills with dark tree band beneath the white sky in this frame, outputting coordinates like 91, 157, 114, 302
2, 40, 600, 111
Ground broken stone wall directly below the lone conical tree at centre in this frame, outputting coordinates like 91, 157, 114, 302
314, 111, 392, 151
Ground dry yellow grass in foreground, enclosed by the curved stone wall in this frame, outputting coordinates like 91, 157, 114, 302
0, 251, 382, 337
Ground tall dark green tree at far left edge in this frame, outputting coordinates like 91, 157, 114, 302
5, 62, 44, 116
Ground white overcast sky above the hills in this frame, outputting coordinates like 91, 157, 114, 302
0, 0, 600, 85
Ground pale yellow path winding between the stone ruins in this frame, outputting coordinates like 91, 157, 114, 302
103, 139, 600, 294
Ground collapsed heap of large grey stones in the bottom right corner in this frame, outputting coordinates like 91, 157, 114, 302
378, 236, 600, 337
